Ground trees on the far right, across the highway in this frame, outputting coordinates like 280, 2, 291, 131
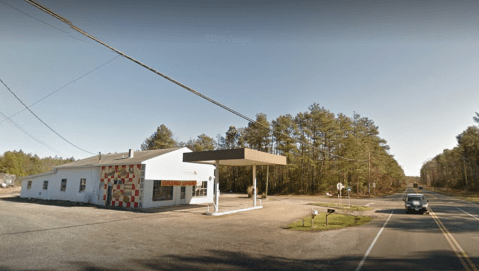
421, 113, 479, 191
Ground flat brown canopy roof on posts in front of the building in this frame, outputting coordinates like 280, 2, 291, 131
183, 148, 286, 166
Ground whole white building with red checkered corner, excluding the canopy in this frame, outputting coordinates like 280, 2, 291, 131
20, 148, 215, 208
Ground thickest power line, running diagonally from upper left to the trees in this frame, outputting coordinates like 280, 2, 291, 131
25, 0, 367, 161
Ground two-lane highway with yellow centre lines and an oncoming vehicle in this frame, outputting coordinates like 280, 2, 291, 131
356, 187, 479, 270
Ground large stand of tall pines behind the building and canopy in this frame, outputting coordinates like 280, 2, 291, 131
141, 103, 405, 194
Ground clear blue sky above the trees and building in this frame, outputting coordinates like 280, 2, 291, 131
0, 0, 479, 176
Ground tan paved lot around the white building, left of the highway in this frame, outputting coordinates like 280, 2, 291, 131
0, 194, 396, 270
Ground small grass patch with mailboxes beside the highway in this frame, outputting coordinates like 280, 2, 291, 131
287, 213, 373, 231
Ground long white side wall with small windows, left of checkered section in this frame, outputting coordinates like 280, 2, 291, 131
20, 167, 100, 204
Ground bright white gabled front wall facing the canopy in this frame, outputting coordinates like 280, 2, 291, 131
143, 148, 215, 208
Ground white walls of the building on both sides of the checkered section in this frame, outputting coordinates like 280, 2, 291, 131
20, 148, 215, 208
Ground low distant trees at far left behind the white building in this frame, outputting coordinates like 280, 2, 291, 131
0, 150, 75, 177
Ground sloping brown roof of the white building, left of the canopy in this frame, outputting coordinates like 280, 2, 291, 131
55, 148, 180, 169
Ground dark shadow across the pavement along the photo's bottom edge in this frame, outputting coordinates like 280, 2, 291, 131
0, 250, 479, 271
